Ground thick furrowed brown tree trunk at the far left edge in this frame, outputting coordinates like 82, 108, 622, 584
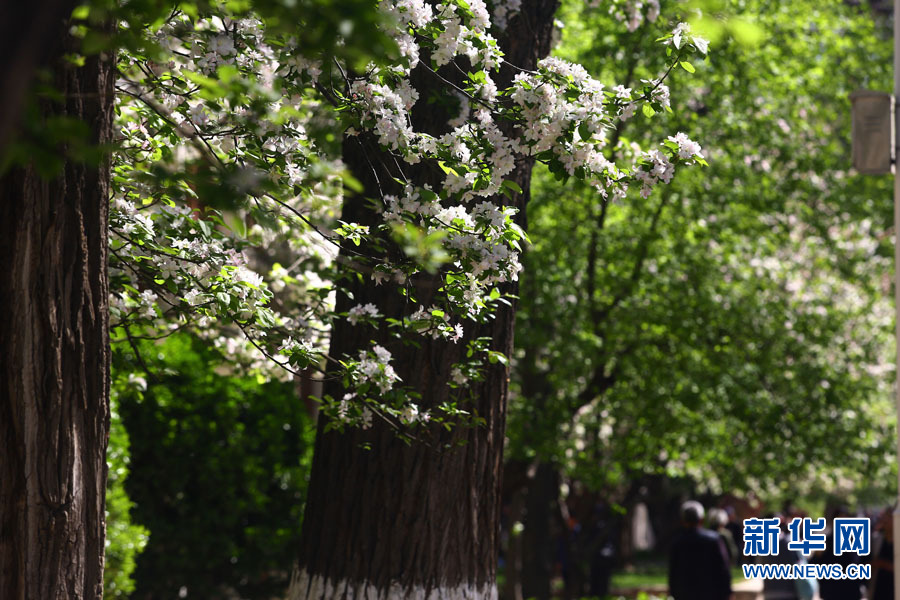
0, 18, 114, 600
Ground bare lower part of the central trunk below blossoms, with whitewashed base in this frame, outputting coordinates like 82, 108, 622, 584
290, 294, 512, 600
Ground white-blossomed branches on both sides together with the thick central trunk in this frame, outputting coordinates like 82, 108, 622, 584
102, 0, 707, 598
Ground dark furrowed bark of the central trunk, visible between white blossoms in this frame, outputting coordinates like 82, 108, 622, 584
289, 0, 558, 600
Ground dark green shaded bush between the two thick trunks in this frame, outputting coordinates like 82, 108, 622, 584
115, 334, 313, 598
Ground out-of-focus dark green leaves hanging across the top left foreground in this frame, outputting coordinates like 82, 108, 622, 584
0, 0, 397, 175
